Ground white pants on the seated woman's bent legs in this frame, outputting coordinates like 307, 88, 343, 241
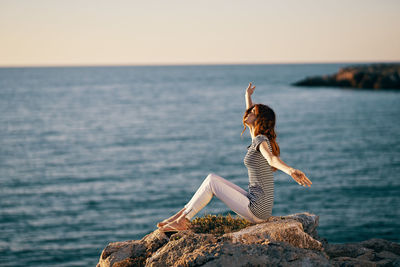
184, 173, 264, 223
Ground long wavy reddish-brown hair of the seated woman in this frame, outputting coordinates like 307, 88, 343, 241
240, 104, 280, 172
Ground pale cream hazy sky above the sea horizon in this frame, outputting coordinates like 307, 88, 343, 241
0, 0, 400, 67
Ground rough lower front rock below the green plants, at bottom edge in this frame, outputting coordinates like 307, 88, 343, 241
146, 234, 329, 266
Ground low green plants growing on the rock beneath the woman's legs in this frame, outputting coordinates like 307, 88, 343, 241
191, 214, 254, 236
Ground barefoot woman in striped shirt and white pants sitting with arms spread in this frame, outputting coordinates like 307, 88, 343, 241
157, 83, 312, 232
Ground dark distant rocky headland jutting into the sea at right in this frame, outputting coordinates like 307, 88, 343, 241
292, 63, 400, 89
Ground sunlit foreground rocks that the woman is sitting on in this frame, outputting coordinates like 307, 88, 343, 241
97, 212, 400, 267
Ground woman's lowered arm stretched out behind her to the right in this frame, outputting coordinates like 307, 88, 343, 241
260, 141, 312, 187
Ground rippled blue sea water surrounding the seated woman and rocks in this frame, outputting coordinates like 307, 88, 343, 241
0, 63, 400, 266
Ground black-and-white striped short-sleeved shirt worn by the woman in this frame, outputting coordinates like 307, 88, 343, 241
244, 135, 274, 220
